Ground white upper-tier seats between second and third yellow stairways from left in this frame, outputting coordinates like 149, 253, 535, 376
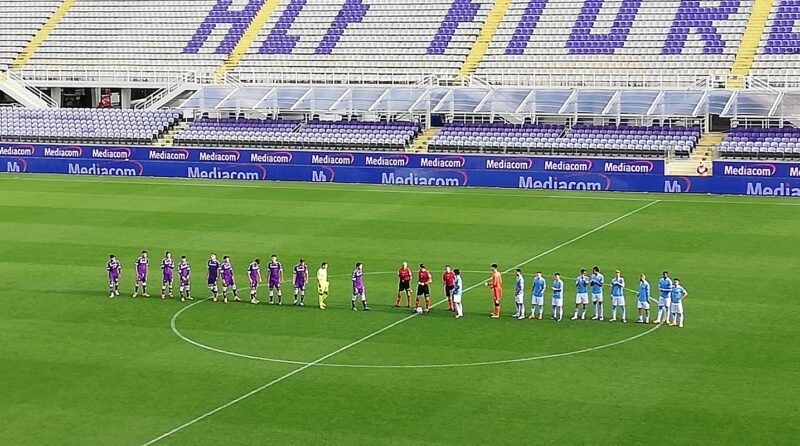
235, 0, 493, 81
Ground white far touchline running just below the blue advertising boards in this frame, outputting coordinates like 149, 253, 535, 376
6, 174, 800, 206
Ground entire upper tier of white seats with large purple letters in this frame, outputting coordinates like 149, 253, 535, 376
0, 0, 800, 83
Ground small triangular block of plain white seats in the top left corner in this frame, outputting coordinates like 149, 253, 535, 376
0, 0, 61, 71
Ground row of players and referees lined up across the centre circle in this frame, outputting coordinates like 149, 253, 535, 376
106, 251, 688, 327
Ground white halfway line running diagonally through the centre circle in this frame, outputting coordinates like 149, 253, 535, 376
142, 200, 660, 446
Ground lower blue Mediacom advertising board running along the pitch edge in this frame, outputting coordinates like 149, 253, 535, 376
0, 156, 800, 197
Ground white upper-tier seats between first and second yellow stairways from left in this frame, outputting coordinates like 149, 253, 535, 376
26, 0, 233, 75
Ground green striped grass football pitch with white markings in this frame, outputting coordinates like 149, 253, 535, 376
0, 175, 800, 445
